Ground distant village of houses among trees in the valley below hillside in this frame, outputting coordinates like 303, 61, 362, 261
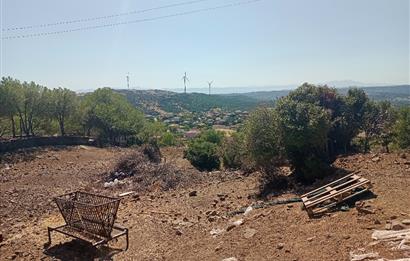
146, 108, 249, 139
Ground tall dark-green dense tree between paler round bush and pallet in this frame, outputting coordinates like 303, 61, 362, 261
275, 97, 331, 181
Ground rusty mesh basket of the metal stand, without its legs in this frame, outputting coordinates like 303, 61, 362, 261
54, 191, 120, 239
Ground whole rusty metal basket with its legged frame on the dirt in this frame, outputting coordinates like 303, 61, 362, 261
48, 191, 128, 250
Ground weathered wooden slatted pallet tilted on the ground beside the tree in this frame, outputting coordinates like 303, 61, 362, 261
301, 172, 371, 217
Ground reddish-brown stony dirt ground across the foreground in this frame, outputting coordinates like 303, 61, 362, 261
0, 146, 410, 261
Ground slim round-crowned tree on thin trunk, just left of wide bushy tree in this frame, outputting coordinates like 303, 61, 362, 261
50, 87, 78, 136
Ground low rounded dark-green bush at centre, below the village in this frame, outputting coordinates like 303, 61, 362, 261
185, 130, 223, 171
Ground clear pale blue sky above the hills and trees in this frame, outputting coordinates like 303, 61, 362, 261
0, 0, 410, 91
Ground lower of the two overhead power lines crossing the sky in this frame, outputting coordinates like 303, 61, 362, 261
1, 0, 263, 40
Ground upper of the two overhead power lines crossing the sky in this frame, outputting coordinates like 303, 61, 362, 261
2, 0, 213, 31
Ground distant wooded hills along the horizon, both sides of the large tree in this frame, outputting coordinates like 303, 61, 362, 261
115, 85, 410, 115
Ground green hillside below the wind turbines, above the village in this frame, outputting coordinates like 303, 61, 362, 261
116, 90, 262, 114
